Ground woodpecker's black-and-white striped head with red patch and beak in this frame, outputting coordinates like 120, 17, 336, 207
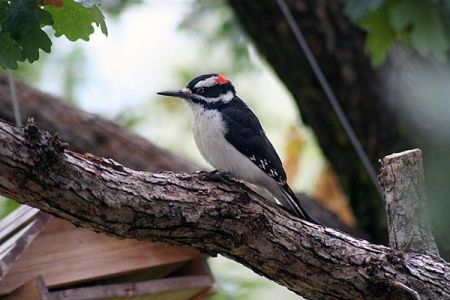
158, 74, 236, 107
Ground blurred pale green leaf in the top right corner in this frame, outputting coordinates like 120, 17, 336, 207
389, 0, 450, 61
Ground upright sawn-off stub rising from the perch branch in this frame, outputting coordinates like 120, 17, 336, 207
379, 149, 439, 256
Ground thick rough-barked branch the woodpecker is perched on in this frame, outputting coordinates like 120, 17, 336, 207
0, 122, 450, 300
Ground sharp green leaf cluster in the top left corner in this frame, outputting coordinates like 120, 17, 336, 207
0, 0, 107, 69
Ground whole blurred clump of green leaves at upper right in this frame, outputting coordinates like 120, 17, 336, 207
345, 0, 450, 66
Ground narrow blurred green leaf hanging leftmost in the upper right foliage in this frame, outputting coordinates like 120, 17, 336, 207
361, 5, 394, 66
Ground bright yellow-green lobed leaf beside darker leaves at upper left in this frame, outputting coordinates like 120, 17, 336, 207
45, 0, 107, 41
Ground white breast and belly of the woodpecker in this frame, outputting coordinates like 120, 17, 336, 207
191, 104, 278, 190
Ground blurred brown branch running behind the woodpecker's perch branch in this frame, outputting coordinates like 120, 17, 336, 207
0, 75, 367, 238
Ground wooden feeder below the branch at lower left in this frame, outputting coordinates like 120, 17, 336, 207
0, 206, 214, 300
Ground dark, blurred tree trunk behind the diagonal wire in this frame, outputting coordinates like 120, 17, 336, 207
228, 0, 407, 242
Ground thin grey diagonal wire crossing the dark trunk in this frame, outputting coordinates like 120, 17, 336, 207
276, 0, 384, 199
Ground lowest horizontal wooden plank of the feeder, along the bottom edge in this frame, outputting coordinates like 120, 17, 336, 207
50, 275, 213, 300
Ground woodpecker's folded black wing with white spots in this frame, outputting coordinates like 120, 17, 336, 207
221, 97, 286, 185
